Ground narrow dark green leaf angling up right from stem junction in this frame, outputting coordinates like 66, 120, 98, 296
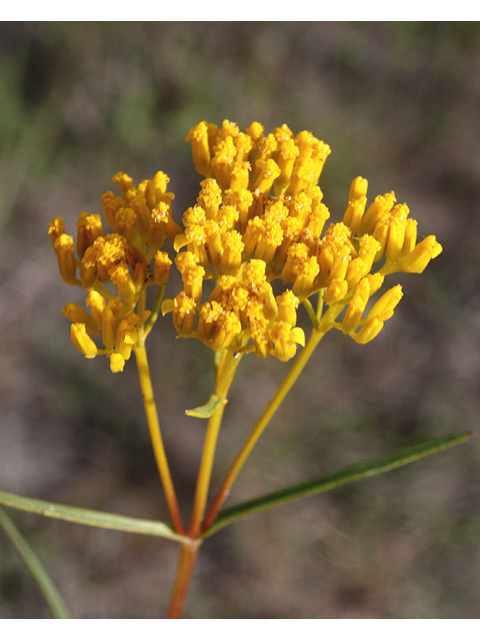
202, 432, 474, 538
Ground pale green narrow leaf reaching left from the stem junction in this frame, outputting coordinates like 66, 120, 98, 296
0, 491, 188, 542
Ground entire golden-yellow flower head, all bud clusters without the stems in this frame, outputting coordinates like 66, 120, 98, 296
49, 120, 442, 371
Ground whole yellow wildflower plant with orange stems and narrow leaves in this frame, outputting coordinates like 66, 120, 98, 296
0, 120, 471, 617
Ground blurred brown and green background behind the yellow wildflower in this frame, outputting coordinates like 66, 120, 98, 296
0, 22, 480, 618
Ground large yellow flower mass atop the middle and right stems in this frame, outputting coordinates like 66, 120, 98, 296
162, 120, 442, 361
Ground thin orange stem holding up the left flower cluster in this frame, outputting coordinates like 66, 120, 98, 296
135, 344, 185, 535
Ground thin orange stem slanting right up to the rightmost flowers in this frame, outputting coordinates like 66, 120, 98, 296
202, 323, 330, 532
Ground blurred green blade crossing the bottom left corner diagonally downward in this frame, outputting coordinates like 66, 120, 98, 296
0, 507, 70, 618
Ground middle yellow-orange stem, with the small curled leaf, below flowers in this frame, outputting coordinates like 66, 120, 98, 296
188, 350, 241, 539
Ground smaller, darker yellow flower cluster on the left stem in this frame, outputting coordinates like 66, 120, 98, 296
48, 171, 181, 372
